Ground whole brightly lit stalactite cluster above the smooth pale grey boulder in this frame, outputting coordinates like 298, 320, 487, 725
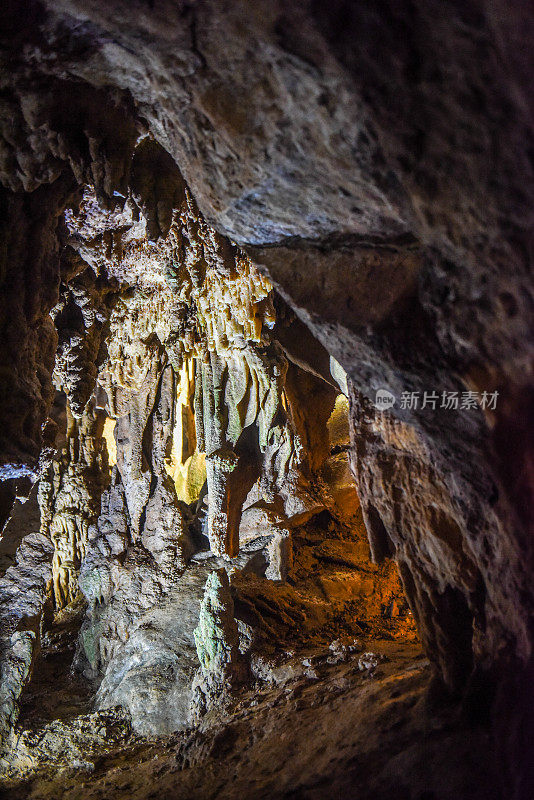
15, 178, 320, 703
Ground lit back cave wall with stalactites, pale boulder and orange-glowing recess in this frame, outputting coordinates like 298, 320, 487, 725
3, 173, 378, 744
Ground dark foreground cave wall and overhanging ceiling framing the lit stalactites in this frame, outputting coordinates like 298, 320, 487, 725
1, 0, 533, 776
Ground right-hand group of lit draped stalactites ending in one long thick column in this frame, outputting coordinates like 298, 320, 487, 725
171, 244, 296, 556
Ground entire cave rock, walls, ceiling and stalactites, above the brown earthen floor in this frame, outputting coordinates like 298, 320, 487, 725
0, 0, 534, 800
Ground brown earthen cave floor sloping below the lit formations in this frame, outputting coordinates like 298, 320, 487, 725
3, 638, 501, 800
